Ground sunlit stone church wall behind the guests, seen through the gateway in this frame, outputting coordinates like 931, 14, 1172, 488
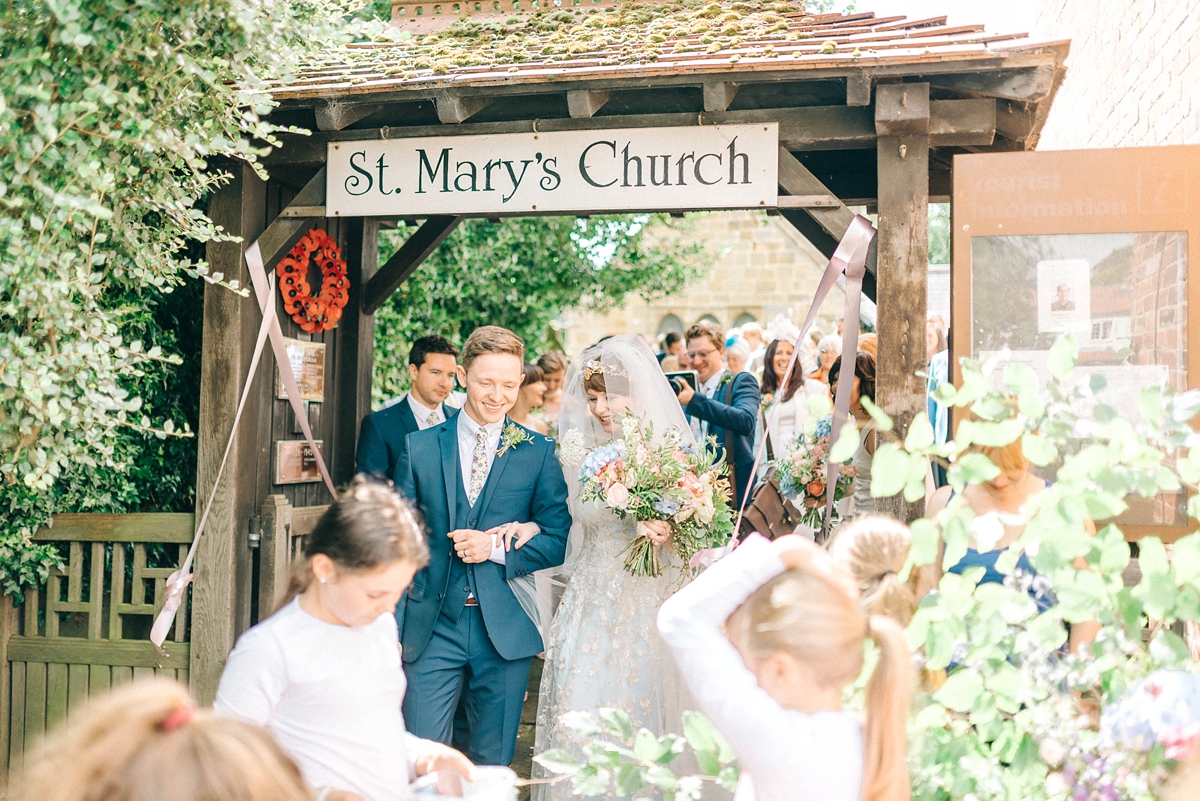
565, 211, 844, 354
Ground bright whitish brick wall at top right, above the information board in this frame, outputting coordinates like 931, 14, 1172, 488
1033, 0, 1200, 150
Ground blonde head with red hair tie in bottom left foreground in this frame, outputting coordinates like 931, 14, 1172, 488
15, 679, 313, 801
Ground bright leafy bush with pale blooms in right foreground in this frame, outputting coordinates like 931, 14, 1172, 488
870, 337, 1200, 801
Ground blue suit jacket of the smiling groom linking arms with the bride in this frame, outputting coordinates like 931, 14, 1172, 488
395, 417, 571, 662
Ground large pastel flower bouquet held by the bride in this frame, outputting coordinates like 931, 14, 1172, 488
563, 411, 733, 577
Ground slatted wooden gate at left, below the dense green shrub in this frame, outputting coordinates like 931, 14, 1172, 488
0, 513, 194, 772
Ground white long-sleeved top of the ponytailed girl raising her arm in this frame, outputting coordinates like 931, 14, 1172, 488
659, 536, 863, 801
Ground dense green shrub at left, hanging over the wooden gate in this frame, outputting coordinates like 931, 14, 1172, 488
0, 0, 360, 592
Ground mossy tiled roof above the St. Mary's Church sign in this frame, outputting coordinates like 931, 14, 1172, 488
275, 0, 1062, 101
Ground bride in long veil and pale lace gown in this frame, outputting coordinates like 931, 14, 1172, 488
533, 336, 695, 801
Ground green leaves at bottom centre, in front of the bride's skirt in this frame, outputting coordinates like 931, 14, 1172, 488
533, 709, 738, 801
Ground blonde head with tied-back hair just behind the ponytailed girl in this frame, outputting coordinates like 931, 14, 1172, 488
829, 514, 922, 626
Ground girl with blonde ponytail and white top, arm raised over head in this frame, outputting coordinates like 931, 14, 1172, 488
659, 535, 911, 801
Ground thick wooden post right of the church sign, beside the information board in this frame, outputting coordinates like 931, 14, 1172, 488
875, 84, 929, 522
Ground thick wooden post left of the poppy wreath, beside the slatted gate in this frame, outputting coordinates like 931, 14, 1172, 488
190, 163, 270, 705
